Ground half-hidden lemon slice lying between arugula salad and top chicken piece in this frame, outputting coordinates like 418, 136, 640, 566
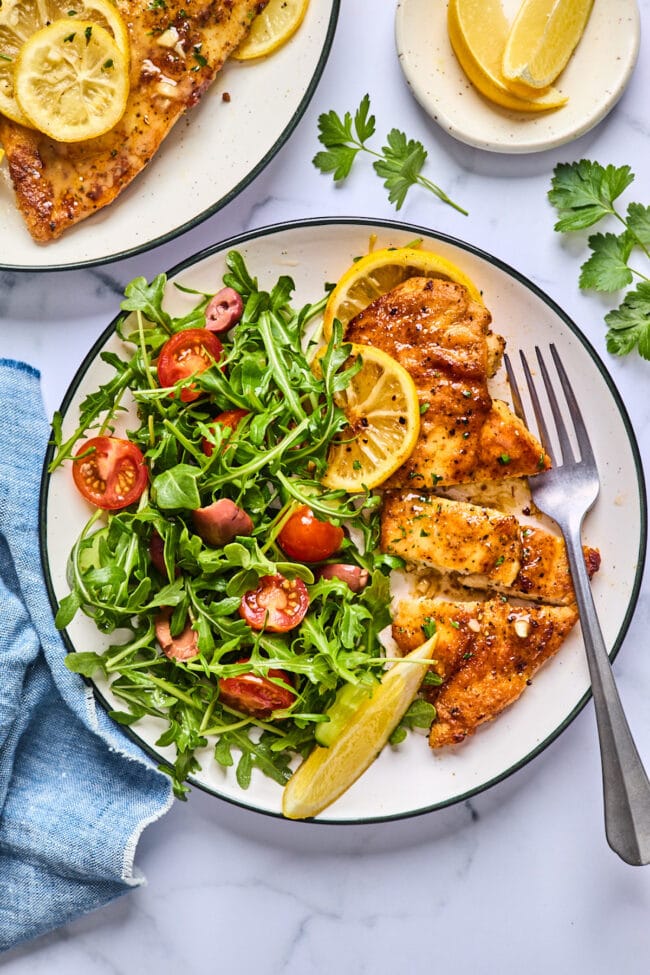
323, 345, 420, 493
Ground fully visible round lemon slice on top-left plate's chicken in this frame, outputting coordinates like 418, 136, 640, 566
14, 18, 129, 142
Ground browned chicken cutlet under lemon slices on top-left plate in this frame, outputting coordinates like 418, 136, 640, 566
0, 0, 267, 242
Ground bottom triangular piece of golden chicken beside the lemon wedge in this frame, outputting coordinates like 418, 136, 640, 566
392, 598, 578, 748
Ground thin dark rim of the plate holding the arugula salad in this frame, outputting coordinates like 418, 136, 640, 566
38, 216, 648, 826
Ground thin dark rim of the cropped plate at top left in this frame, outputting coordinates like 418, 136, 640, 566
0, 0, 341, 274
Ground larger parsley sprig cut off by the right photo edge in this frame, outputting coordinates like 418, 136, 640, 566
548, 159, 650, 359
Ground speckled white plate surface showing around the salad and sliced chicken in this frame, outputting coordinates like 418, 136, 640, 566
41, 219, 646, 822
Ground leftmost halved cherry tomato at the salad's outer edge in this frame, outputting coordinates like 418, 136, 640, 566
72, 437, 149, 511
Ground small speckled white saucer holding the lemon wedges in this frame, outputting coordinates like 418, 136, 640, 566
395, 0, 640, 152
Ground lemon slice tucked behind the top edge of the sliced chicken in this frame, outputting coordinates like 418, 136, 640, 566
323, 247, 482, 339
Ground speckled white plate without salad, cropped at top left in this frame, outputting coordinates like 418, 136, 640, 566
0, 0, 340, 270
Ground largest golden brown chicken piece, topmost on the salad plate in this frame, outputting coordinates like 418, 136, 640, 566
345, 277, 550, 490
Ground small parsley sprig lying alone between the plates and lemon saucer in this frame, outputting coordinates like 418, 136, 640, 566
312, 95, 467, 216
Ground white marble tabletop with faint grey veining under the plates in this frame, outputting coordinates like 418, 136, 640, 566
0, 0, 650, 975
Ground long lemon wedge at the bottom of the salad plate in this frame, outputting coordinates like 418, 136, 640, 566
282, 635, 436, 819
